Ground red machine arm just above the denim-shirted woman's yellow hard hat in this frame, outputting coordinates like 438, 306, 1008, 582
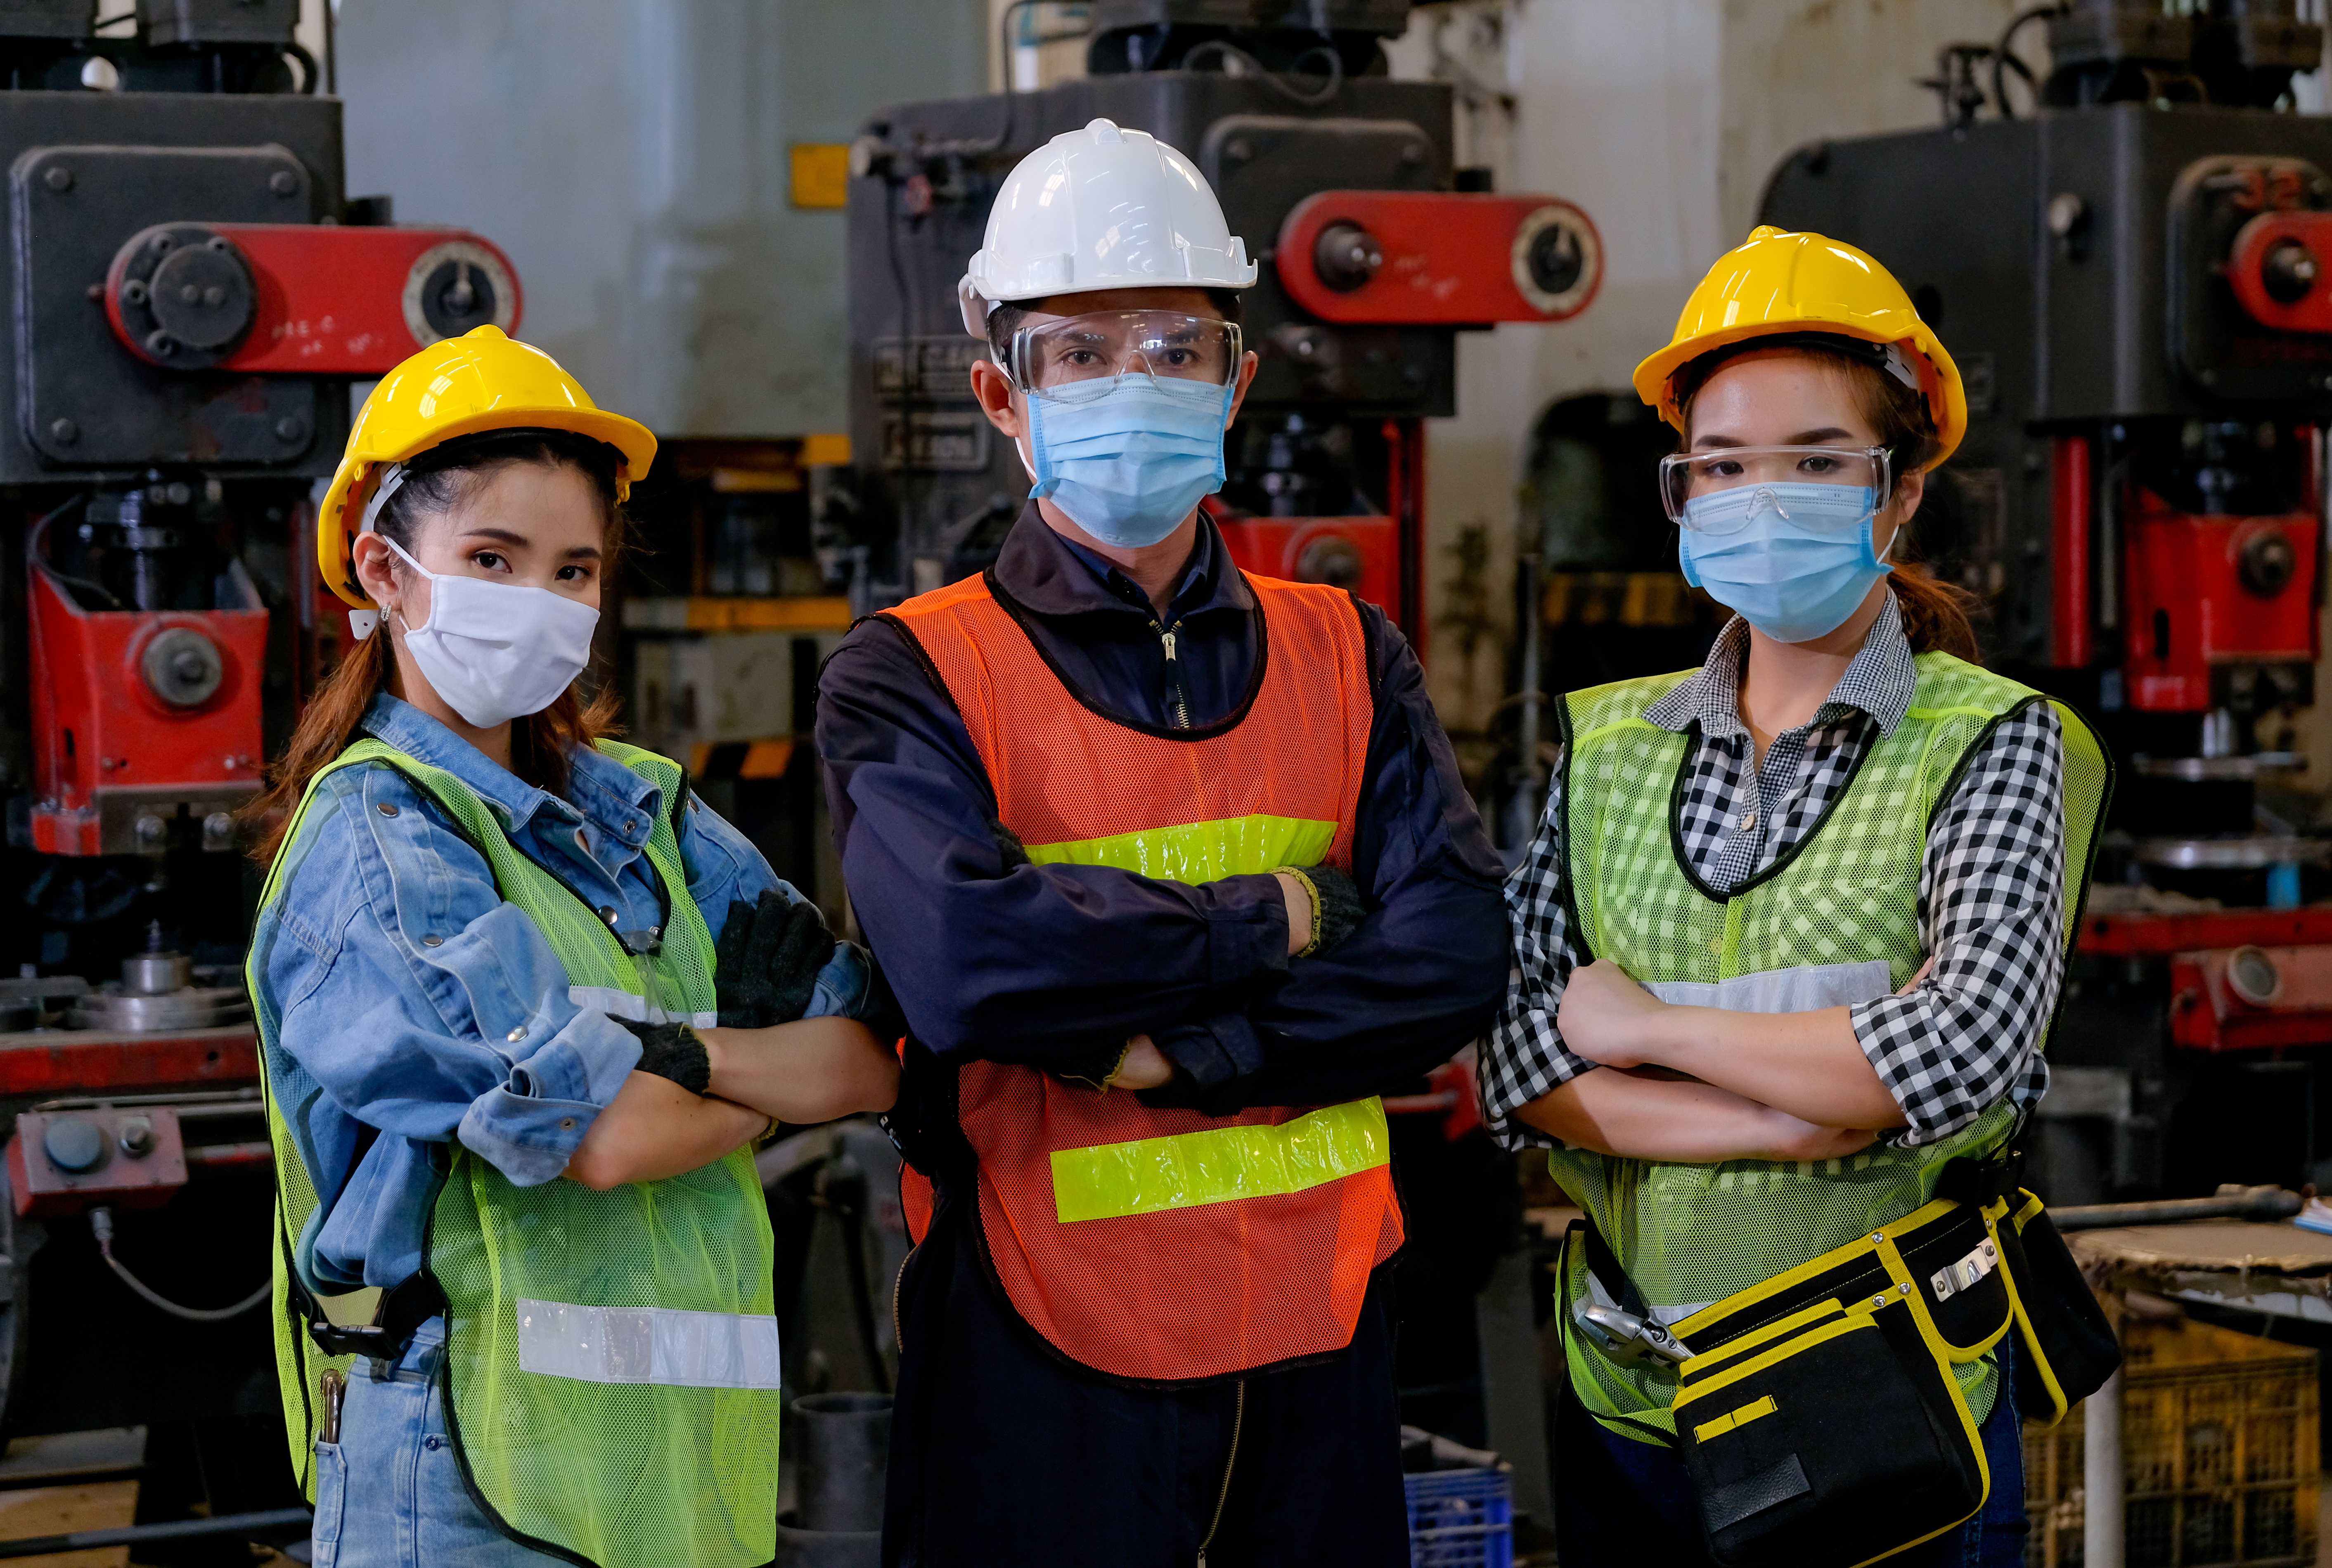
105, 224, 522, 375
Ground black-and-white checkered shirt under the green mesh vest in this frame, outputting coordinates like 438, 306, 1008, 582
1481, 596, 2064, 1149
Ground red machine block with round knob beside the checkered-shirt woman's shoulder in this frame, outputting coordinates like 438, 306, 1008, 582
2117, 487, 2315, 713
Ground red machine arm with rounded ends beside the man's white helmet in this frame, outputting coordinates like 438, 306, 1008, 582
1276, 191, 1602, 326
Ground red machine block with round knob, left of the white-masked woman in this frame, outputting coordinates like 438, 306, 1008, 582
26, 545, 268, 855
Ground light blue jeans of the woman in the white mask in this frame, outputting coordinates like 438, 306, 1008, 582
310, 1319, 562, 1568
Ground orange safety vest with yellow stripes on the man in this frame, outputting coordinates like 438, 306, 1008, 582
891, 575, 1402, 1384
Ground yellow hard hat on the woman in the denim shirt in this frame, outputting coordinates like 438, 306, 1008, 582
315, 326, 655, 610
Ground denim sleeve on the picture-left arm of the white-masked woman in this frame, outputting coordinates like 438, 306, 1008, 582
263, 766, 639, 1186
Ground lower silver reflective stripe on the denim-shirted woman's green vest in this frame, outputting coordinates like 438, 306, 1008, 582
518, 1296, 779, 1388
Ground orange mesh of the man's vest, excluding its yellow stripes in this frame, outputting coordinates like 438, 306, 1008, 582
893, 578, 1402, 1381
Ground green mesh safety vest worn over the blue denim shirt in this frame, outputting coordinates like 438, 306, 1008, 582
247, 738, 779, 1568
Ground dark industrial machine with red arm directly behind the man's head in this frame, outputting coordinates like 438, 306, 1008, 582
849, 0, 1602, 639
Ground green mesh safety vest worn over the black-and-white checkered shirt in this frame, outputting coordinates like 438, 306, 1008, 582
1548, 653, 2110, 1442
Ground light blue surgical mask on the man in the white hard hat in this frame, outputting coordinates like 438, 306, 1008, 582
1028, 373, 1236, 550
